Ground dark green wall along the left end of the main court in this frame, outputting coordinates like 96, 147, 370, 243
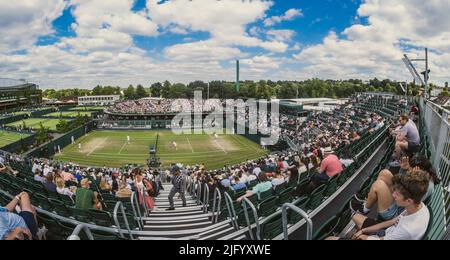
25, 121, 94, 158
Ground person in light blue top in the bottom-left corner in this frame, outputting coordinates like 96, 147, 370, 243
0, 192, 38, 240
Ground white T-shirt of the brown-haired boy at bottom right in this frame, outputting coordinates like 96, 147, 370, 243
374, 203, 430, 240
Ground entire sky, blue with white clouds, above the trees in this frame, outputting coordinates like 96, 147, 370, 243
0, 0, 450, 88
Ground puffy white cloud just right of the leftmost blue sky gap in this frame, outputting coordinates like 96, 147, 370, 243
61, 0, 158, 52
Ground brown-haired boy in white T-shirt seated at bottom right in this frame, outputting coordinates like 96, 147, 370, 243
328, 170, 430, 240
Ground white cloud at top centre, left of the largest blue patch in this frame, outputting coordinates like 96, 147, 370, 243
147, 0, 287, 52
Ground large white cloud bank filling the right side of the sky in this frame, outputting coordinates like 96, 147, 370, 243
294, 0, 450, 83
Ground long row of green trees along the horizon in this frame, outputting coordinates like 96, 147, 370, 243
43, 78, 448, 100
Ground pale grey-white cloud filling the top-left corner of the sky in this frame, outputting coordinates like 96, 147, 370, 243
0, 0, 65, 52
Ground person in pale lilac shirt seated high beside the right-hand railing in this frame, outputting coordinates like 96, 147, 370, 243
394, 115, 420, 160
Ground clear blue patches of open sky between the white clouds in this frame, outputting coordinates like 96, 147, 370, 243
36, 0, 361, 54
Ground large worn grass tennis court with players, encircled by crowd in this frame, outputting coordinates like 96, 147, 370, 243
55, 130, 267, 169
